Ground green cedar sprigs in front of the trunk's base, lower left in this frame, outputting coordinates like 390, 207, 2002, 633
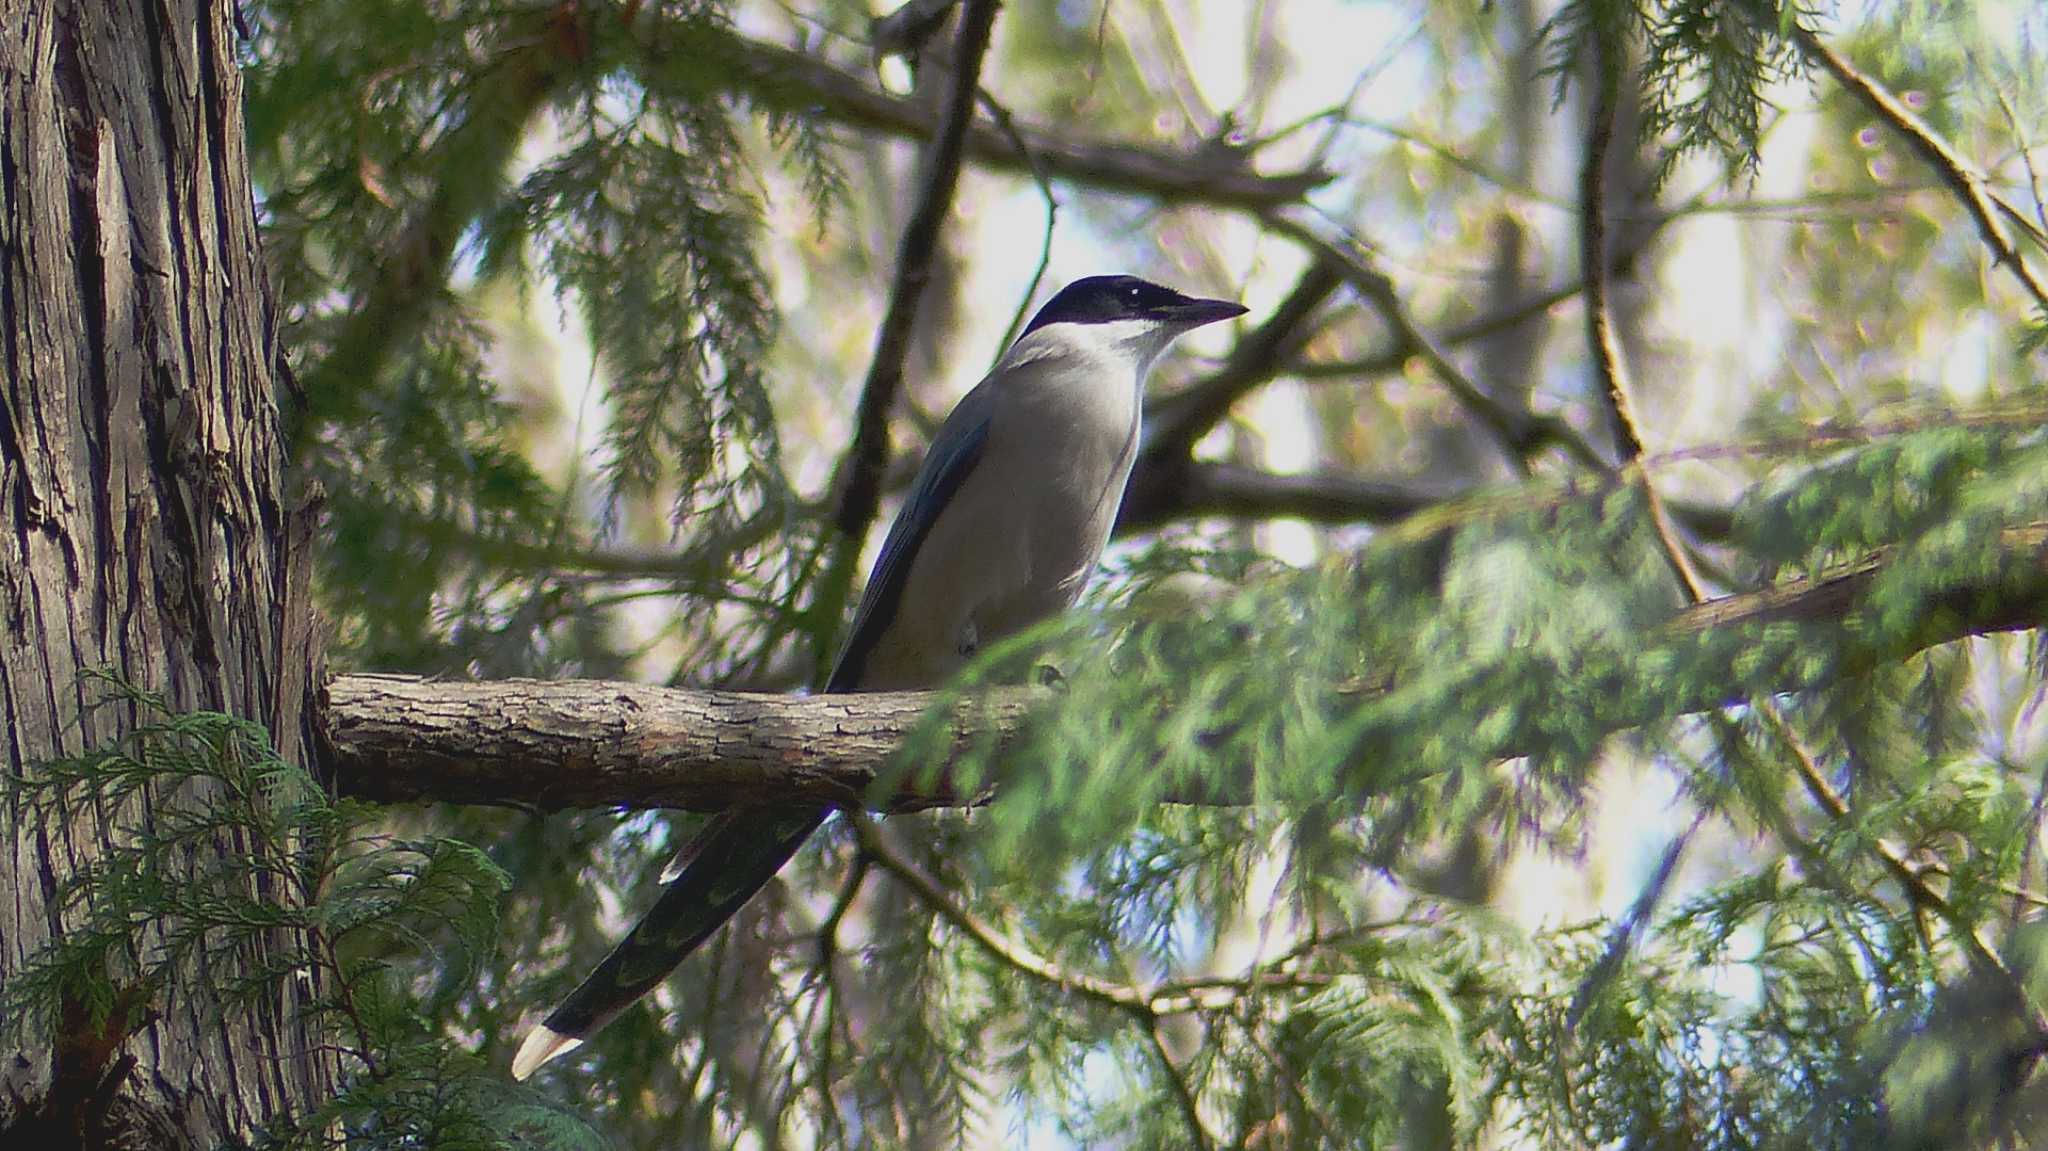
0, 676, 602, 1151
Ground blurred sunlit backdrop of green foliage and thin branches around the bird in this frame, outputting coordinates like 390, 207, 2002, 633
242, 0, 2048, 1147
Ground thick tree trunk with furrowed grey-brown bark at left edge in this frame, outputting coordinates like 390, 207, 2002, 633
0, 0, 330, 1147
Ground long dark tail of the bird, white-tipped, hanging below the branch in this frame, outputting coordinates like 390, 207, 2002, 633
512, 807, 829, 1079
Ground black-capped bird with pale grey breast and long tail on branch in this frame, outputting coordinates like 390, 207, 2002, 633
512, 274, 1245, 1079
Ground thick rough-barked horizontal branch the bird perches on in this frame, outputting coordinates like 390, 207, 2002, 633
319, 524, 2048, 809
